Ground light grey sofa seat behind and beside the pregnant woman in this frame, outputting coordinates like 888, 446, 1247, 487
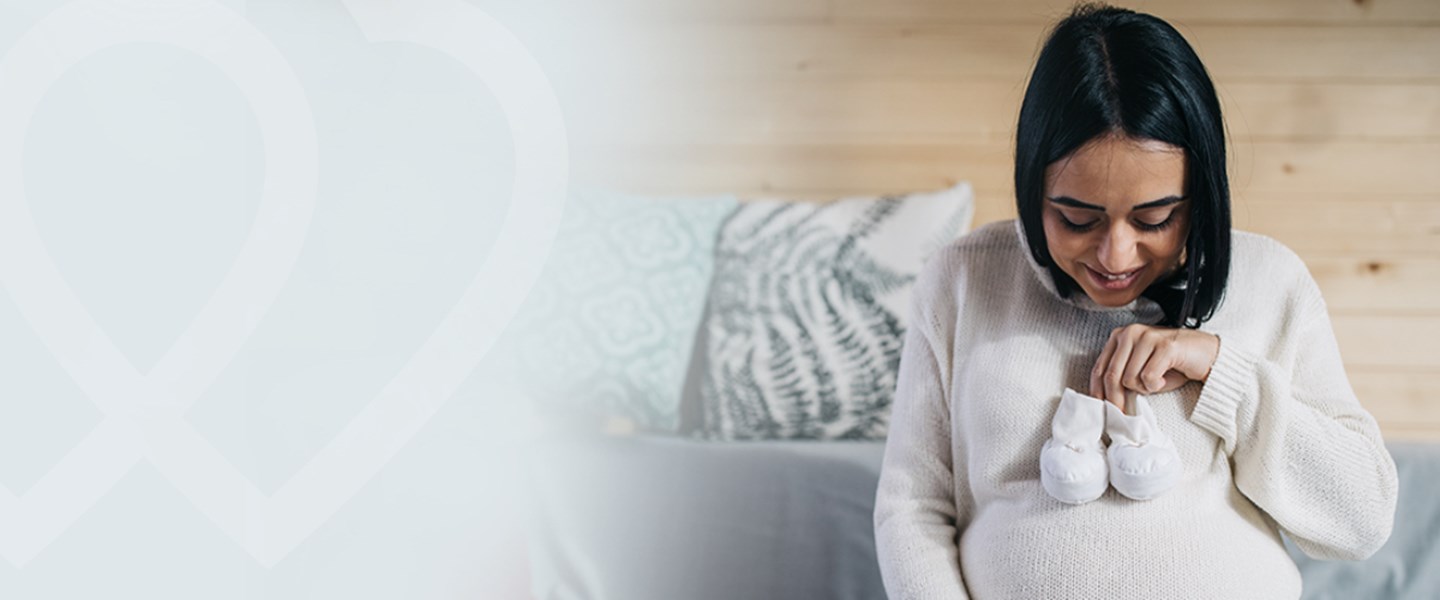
526, 435, 1440, 600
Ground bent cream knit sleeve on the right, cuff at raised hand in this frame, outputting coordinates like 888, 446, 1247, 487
1191, 272, 1397, 560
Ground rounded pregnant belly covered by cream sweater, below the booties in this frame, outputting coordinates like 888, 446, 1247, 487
960, 483, 1300, 600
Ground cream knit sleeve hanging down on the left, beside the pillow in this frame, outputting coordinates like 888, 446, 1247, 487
874, 273, 969, 600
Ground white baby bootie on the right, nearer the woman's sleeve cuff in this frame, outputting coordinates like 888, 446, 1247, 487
1104, 394, 1184, 499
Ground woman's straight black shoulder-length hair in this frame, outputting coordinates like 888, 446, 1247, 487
1015, 4, 1230, 328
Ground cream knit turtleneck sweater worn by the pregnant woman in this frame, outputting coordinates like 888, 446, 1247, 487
874, 220, 1395, 600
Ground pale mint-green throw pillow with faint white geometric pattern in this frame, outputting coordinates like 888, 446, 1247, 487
494, 188, 739, 433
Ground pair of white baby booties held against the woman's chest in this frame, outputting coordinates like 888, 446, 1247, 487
1040, 387, 1184, 504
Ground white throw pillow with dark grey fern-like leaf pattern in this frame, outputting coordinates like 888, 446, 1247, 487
690, 183, 975, 440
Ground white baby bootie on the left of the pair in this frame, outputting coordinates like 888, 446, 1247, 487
1040, 387, 1109, 504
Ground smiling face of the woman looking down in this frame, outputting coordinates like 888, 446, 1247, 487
1041, 135, 1191, 306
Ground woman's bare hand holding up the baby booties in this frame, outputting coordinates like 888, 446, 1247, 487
1090, 324, 1220, 410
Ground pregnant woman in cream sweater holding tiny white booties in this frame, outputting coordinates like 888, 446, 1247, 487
874, 6, 1397, 600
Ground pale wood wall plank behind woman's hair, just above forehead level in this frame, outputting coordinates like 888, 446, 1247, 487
570, 78, 1440, 144
